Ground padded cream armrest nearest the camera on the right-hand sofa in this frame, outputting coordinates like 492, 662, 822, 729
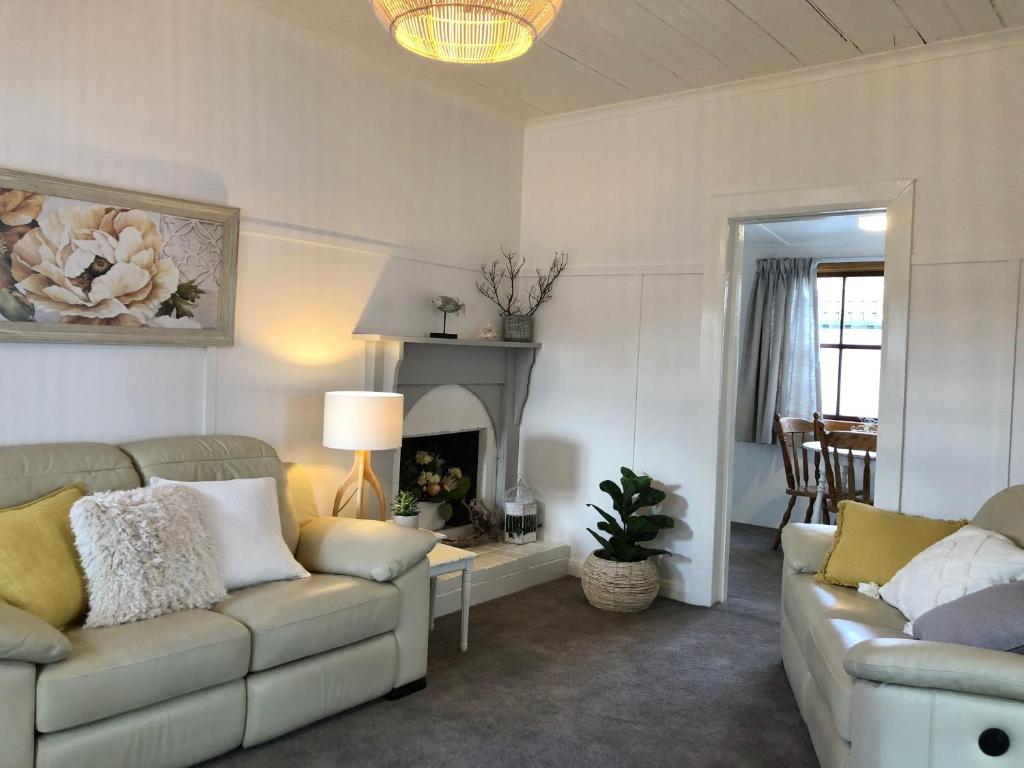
843, 638, 1024, 701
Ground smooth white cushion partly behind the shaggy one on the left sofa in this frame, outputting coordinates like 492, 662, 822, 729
150, 477, 309, 590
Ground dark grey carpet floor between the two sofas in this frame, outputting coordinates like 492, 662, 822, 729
205, 524, 818, 768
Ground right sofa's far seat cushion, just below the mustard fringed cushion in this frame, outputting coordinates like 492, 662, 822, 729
782, 572, 906, 653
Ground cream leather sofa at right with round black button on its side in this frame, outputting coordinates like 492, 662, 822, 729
782, 485, 1024, 768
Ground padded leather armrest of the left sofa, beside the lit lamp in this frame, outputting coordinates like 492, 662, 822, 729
295, 517, 438, 582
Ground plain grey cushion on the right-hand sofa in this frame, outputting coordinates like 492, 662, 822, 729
913, 582, 1024, 653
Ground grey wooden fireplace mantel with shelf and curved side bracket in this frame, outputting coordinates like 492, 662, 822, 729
352, 333, 541, 514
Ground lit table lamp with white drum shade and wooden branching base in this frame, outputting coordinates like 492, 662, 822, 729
324, 392, 404, 520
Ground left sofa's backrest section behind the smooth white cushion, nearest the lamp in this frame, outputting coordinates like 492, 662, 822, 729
121, 435, 299, 552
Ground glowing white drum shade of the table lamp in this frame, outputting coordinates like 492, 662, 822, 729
324, 392, 404, 451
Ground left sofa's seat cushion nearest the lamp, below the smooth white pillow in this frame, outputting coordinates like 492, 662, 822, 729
214, 573, 398, 672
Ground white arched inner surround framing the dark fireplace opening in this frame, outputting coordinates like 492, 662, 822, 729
391, 384, 504, 512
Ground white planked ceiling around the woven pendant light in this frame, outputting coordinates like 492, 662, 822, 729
278, 0, 1024, 118
